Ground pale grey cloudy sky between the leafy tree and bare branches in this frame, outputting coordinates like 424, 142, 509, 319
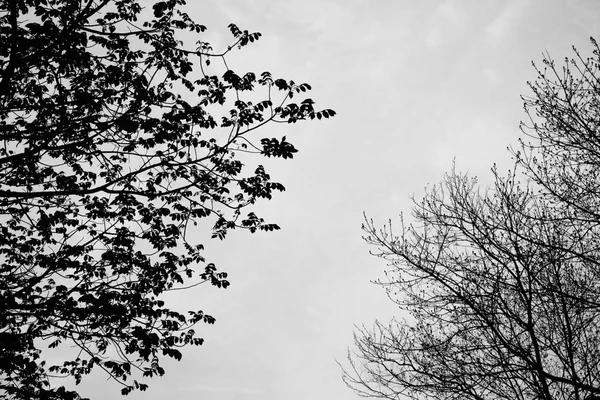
77, 0, 600, 400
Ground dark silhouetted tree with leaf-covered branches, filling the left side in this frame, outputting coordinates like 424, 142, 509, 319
0, 0, 335, 399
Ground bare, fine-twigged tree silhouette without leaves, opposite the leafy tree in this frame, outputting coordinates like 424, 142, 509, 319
344, 40, 600, 400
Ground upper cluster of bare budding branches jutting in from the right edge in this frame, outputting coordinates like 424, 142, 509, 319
513, 38, 600, 223
